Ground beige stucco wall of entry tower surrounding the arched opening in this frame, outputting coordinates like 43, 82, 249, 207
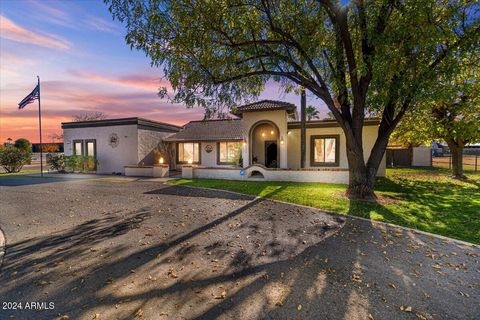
243, 110, 288, 168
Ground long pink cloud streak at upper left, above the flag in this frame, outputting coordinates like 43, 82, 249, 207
0, 15, 71, 50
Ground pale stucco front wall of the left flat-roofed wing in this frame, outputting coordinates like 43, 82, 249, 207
63, 125, 138, 174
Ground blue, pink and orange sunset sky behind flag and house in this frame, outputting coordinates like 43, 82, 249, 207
0, 0, 326, 143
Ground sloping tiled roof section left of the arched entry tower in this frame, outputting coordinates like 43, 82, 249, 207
165, 119, 243, 142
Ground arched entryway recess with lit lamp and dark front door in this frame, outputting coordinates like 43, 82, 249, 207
249, 120, 280, 168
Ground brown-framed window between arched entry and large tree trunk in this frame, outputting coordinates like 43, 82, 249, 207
310, 135, 339, 166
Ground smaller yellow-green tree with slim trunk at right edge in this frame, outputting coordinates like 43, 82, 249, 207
393, 56, 480, 179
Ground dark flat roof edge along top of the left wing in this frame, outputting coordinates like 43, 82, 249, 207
62, 117, 182, 132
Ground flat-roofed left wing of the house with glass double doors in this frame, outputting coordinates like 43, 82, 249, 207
62, 118, 181, 174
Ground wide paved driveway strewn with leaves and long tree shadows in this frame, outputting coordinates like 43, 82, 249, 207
0, 178, 480, 319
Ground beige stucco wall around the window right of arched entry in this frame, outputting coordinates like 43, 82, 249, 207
287, 126, 386, 176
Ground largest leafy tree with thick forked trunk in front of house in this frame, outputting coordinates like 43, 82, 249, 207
105, 0, 480, 199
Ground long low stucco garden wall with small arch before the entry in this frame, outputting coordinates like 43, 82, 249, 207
182, 165, 348, 184
